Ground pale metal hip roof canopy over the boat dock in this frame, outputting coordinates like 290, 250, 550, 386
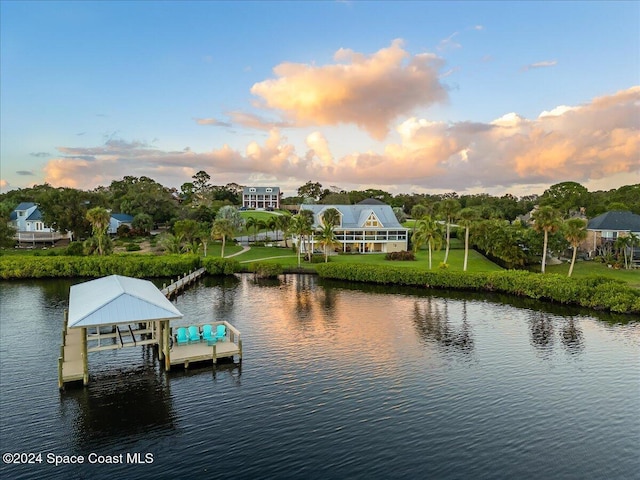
68, 275, 183, 328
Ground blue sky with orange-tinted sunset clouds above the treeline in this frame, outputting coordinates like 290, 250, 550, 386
0, 0, 640, 196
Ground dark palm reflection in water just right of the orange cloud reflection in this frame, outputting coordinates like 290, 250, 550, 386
413, 298, 474, 353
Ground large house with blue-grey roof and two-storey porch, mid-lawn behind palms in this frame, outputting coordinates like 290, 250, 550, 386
294, 202, 408, 253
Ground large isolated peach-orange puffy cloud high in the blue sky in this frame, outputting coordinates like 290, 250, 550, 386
251, 40, 447, 139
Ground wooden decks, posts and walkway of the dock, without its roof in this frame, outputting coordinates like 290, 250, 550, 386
58, 268, 242, 389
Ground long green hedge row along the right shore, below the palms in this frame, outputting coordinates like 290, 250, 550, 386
317, 264, 640, 313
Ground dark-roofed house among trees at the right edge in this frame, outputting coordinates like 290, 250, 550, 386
582, 210, 640, 257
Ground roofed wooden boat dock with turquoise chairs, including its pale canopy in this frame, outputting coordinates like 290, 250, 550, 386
58, 268, 242, 389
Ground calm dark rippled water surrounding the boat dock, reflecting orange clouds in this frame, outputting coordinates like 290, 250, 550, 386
0, 276, 640, 480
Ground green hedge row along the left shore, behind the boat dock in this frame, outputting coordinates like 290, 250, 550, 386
0, 255, 219, 280
